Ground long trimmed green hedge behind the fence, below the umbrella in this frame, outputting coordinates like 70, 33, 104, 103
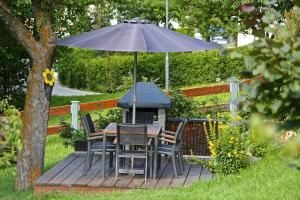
57, 49, 245, 92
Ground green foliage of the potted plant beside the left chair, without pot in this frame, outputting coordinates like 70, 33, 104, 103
59, 118, 87, 146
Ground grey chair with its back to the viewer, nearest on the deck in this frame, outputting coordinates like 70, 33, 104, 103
115, 124, 152, 181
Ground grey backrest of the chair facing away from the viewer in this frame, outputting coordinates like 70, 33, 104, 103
117, 124, 148, 146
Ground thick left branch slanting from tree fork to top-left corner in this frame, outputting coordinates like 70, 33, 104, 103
0, 0, 41, 59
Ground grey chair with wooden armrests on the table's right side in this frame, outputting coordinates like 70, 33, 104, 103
157, 119, 188, 178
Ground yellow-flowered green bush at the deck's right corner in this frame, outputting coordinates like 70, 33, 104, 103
192, 115, 250, 175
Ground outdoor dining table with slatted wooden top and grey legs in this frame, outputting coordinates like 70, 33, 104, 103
102, 123, 163, 179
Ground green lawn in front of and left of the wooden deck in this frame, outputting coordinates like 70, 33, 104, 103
0, 136, 300, 200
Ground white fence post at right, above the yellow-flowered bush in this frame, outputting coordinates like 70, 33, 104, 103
228, 77, 239, 117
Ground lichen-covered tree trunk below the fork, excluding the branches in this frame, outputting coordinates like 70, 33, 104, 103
15, 58, 51, 190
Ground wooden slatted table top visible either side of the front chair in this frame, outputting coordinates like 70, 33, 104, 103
102, 123, 163, 138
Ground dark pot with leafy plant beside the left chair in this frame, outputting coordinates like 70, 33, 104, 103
59, 119, 87, 151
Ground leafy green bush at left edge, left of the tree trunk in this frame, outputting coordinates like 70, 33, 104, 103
0, 99, 22, 167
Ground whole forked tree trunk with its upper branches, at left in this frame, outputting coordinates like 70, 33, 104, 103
0, 0, 56, 190
